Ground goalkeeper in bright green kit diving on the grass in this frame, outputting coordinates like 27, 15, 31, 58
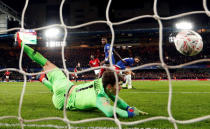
17, 33, 147, 117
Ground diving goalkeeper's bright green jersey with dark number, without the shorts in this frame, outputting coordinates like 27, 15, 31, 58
67, 79, 128, 117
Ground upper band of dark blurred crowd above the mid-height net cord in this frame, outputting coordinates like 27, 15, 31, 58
0, 44, 210, 68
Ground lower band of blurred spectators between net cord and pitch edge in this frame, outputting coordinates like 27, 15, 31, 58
0, 69, 210, 81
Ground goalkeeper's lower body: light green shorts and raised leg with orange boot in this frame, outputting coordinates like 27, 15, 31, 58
17, 31, 74, 109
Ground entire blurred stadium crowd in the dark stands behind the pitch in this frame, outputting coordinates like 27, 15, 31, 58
0, 44, 210, 79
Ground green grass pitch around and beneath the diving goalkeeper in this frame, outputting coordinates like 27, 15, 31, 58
0, 81, 210, 129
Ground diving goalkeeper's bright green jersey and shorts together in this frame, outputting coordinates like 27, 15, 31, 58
44, 68, 128, 117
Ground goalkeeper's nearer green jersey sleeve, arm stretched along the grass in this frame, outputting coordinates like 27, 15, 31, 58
96, 94, 128, 118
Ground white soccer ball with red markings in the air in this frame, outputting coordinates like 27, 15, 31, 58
174, 30, 203, 56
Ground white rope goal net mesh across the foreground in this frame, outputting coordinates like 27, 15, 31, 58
0, 0, 210, 129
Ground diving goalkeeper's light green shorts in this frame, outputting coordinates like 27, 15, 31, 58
47, 68, 74, 109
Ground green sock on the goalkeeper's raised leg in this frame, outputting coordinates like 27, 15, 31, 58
21, 42, 47, 66
